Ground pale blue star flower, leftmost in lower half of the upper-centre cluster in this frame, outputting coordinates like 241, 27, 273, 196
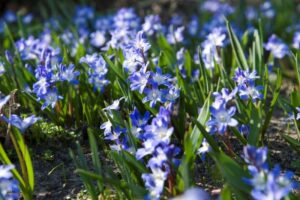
129, 65, 150, 94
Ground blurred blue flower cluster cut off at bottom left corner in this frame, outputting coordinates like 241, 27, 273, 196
0, 165, 20, 200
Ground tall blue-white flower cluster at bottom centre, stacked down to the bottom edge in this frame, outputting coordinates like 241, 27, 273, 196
134, 107, 179, 199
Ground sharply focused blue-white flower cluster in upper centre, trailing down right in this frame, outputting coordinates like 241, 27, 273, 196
123, 32, 179, 107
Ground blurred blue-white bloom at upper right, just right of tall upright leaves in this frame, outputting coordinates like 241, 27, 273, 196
264, 34, 289, 59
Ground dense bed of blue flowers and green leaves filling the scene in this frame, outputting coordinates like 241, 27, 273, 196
0, 0, 300, 200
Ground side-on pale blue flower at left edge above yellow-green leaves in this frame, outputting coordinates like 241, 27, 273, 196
1, 114, 41, 133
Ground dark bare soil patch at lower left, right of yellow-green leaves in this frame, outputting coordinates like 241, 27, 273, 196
33, 140, 89, 200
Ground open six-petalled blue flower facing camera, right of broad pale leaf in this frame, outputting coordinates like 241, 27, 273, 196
206, 101, 238, 134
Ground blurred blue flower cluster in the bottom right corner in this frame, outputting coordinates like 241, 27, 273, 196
244, 145, 297, 200
